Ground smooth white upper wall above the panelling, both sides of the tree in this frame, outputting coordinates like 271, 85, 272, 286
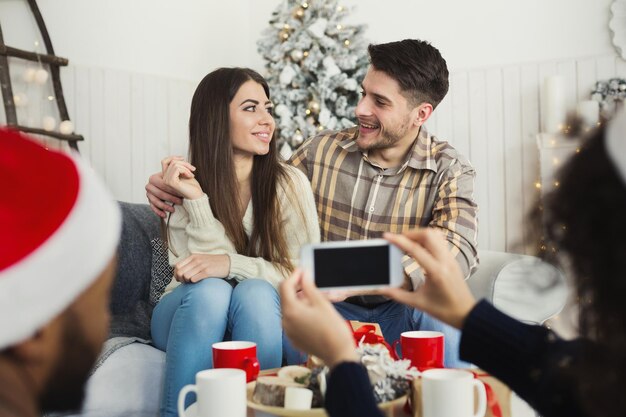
0, 0, 613, 82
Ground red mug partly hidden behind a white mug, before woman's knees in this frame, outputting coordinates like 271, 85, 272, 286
212, 341, 261, 382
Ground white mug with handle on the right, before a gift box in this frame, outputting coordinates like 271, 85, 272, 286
422, 369, 487, 417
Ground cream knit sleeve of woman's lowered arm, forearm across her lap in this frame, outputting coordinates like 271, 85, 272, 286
228, 166, 320, 287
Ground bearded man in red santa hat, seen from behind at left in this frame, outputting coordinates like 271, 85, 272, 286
0, 129, 121, 417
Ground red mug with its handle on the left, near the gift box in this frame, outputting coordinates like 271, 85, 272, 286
392, 330, 444, 371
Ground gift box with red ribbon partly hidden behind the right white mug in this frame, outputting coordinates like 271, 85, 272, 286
411, 369, 511, 417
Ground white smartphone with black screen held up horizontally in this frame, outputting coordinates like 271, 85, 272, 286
300, 239, 404, 290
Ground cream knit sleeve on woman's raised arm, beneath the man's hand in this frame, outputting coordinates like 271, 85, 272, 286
168, 194, 235, 266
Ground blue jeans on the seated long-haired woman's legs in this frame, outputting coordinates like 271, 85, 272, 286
151, 278, 282, 417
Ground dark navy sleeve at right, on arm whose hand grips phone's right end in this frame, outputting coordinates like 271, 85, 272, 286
460, 300, 584, 417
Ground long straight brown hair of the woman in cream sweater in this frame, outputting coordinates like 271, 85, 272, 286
167, 68, 293, 271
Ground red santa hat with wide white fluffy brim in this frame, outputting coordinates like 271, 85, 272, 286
0, 128, 121, 350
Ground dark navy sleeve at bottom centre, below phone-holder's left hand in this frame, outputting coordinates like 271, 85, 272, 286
324, 362, 383, 417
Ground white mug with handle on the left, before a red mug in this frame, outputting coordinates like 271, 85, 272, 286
178, 368, 247, 417
